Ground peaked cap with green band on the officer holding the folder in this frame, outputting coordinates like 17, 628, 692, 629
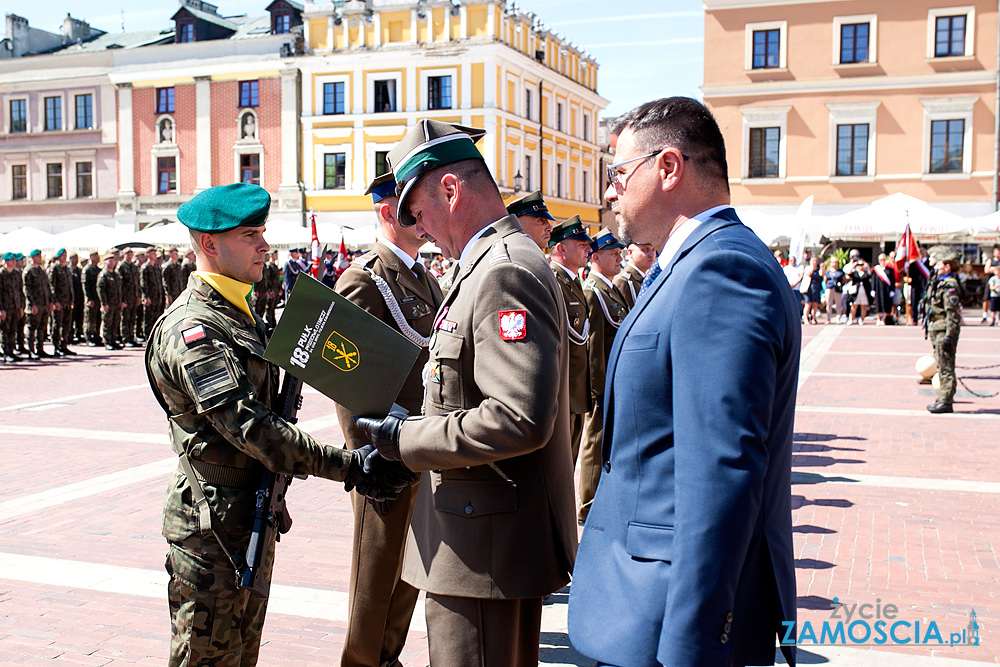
386, 118, 486, 227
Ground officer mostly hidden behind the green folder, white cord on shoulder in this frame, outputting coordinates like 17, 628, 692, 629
336, 173, 442, 667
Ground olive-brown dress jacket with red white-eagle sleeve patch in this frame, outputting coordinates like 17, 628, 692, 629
399, 216, 577, 599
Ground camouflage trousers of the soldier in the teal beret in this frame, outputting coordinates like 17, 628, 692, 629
166, 534, 274, 667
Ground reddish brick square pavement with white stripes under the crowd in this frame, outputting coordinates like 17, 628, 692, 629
0, 321, 1000, 667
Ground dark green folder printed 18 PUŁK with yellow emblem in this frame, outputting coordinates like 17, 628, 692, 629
264, 273, 420, 417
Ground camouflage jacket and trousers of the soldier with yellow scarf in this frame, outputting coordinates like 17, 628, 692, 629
146, 275, 351, 667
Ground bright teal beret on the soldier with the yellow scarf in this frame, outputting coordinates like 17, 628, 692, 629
177, 183, 271, 234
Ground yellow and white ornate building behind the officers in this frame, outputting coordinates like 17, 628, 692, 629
296, 0, 607, 228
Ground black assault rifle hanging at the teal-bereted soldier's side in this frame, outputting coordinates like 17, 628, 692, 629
238, 371, 302, 597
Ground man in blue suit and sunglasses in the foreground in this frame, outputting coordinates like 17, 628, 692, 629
569, 97, 801, 667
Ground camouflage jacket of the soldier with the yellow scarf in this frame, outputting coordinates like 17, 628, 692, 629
146, 275, 350, 546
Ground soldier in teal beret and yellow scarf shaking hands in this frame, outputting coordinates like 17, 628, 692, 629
146, 183, 413, 667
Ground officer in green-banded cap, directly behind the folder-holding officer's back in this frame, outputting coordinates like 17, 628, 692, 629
549, 215, 594, 461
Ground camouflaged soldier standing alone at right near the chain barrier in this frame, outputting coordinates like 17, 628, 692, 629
924, 246, 962, 414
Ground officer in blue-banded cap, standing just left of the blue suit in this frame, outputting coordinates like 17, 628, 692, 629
577, 227, 629, 523
